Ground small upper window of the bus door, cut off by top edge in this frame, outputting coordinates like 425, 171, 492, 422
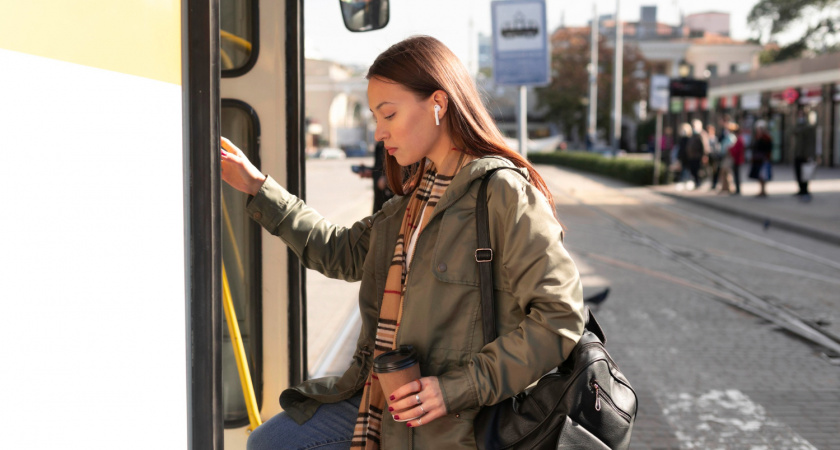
219, 0, 259, 77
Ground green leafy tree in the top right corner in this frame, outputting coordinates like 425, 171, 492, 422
747, 0, 840, 63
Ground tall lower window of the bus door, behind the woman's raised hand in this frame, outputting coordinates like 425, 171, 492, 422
221, 99, 262, 428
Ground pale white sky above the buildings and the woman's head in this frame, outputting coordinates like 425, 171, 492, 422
304, 0, 757, 67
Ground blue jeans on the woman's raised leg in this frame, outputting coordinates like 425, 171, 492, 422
248, 393, 362, 450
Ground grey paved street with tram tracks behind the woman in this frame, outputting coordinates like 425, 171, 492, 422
300, 159, 840, 449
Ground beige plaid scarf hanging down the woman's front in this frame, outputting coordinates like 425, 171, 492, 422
350, 153, 472, 450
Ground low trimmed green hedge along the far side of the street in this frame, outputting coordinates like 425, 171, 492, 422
528, 151, 669, 186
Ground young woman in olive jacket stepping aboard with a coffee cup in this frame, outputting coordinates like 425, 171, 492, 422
222, 36, 584, 450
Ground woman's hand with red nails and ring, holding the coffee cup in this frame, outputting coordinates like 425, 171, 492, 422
389, 377, 446, 427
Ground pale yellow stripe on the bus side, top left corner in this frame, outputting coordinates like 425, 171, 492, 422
0, 0, 181, 85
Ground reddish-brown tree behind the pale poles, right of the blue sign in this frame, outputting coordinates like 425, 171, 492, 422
537, 27, 650, 148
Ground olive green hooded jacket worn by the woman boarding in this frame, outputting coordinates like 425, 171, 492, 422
248, 157, 584, 450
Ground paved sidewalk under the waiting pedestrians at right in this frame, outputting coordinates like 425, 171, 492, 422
651, 165, 840, 245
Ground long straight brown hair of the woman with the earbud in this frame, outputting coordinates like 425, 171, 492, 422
365, 36, 556, 214
